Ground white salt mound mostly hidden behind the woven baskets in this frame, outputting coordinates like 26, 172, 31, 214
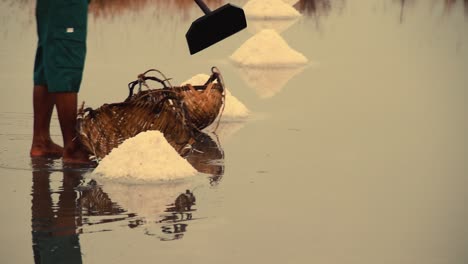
181, 73, 249, 118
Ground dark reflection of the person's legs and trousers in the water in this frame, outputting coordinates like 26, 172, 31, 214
31, 159, 87, 263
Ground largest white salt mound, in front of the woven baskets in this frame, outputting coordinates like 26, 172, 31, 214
94, 131, 197, 180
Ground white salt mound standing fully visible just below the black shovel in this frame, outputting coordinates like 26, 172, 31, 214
230, 29, 308, 68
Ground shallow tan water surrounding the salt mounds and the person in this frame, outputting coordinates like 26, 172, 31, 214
0, 0, 468, 264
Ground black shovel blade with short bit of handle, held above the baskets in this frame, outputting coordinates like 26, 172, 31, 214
185, 0, 247, 55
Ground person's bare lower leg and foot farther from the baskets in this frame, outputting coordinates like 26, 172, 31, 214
30, 85, 63, 157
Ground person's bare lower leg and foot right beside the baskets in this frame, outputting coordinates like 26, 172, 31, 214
54, 92, 89, 163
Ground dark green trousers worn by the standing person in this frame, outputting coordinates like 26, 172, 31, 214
34, 0, 88, 92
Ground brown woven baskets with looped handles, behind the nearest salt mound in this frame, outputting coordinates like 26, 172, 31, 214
78, 68, 224, 158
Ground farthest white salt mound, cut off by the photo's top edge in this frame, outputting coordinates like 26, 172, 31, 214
243, 0, 301, 19
